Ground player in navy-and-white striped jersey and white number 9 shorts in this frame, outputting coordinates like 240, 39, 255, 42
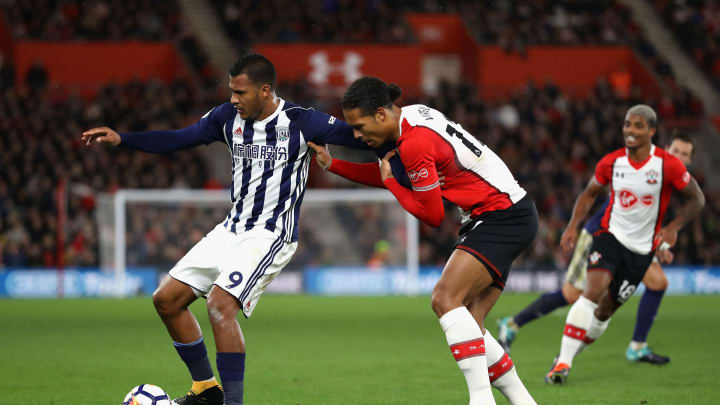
82, 54, 379, 405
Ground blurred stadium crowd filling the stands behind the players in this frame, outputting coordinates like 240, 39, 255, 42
0, 0, 720, 269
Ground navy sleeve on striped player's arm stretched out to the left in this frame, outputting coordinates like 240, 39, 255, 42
120, 103, 235, 153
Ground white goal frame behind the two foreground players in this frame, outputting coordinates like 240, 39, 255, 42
97, 189, 420, 295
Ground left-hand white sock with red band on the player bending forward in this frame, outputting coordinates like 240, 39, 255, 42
440, 307, 495, 405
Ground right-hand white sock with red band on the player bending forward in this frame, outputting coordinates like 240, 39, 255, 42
483, 329, 537, 405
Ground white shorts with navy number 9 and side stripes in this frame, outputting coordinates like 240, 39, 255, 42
170, 224, 297, 318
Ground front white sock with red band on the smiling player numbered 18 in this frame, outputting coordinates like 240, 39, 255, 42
558, 296, 596, 366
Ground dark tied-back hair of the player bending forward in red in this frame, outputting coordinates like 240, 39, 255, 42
342, 76, 402, 115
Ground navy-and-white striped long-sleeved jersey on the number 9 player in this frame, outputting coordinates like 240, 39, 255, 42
121, 99, 367, 242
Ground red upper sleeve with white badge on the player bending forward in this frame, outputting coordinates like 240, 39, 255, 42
398, 128, 440, 191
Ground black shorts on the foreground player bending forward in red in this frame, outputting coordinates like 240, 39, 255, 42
455, 196, 538, 291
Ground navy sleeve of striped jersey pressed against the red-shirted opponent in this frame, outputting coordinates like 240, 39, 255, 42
298, 109, 370, 149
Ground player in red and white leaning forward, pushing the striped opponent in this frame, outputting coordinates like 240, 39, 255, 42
308, 77, 538, 405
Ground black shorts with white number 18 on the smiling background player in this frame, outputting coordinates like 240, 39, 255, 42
588, 232, 655, 304
